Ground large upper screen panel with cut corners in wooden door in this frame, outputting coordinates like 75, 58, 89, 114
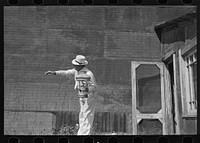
136, 64, 161, 113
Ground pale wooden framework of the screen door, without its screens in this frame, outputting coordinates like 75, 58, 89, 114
131, 61, 167, 135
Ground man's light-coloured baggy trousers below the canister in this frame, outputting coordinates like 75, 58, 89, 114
77, 92, 97, 135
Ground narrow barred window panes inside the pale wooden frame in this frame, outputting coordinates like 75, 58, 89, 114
185, 52, 197, 112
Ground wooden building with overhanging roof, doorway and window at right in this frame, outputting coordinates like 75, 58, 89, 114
155, 11, 197, 134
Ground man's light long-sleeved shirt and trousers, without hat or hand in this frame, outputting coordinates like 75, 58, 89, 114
56, 67, 97, 135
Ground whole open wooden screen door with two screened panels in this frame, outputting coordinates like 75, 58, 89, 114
131, 61, 169, 135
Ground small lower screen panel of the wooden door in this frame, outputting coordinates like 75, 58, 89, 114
137, 119, 162, 135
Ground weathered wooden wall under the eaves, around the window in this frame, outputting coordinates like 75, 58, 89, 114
161, 14, 197, 134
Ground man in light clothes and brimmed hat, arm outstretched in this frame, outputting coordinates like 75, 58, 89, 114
45, 55, 97, 135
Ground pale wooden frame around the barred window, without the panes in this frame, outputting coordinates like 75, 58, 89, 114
179, 44, 198, 117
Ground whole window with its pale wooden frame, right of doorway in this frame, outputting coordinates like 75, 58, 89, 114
179, 48, 197, 117
